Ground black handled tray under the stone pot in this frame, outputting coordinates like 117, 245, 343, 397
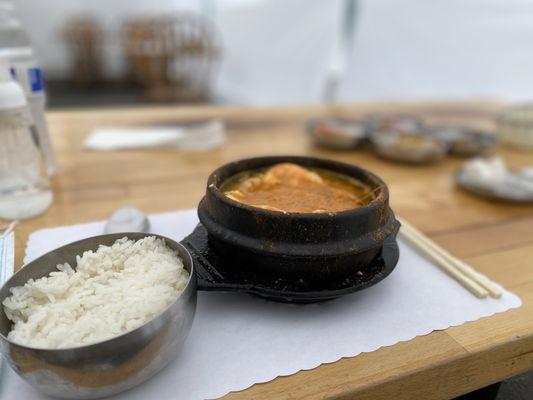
181, 224, 399, 303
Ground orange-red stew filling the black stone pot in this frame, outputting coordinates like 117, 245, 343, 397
221, 163, 379, 213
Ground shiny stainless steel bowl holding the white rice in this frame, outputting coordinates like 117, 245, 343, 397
0, 233, 196, 399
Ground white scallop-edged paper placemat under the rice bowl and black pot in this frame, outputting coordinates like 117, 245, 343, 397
2, 210, 521, 400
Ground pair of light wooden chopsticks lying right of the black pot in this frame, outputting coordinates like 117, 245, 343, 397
400, 219, 502, 298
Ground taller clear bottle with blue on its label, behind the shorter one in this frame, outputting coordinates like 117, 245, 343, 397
0, 2, 56, 176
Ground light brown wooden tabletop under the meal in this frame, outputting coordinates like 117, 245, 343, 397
9, 102, 533, 400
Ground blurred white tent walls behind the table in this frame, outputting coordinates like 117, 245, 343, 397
12, 0, 533, 104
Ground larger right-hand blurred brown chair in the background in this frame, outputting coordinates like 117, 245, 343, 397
122, 14, 220, 101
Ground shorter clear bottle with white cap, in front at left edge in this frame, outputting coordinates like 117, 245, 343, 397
0, 64, 52, 219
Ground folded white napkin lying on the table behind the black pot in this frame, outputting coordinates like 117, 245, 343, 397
83, 120, 226, 151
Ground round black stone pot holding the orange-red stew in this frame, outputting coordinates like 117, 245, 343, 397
198, 156, 399, 282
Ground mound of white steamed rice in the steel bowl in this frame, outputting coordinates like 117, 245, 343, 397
2, 236, 189, 349
